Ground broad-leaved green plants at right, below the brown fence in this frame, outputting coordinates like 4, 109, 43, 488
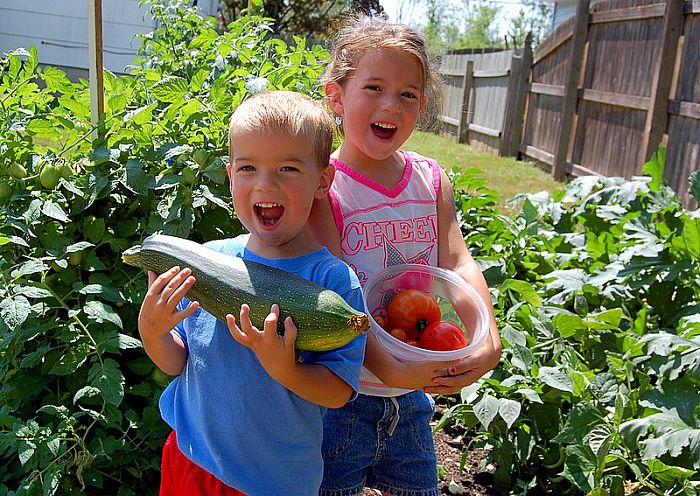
442, 153, 700, 496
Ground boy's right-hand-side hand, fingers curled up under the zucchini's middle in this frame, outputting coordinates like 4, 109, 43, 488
226, 304, 297, 384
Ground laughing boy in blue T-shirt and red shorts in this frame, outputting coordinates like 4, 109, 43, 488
139, 91, 365, 496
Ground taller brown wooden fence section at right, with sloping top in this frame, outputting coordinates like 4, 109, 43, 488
520, 0, 700, 204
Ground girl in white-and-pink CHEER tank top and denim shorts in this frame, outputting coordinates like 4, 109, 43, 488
313, 20, 501, 496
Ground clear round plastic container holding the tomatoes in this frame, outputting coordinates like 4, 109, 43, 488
364, 264, 490, 361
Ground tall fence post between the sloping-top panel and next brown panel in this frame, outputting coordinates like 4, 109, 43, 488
552, 0, 589, 181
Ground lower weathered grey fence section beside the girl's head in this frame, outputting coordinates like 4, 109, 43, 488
438, 43, 532, 155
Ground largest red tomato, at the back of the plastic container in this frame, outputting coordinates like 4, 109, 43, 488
386, 289, 442, 339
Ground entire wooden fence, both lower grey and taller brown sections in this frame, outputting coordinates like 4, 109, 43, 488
438, 0, 700, 207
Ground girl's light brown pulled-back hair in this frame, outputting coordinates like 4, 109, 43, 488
322, 16, 442, 125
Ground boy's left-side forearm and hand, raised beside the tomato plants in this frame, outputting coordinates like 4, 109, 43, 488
138, 267, 199, 375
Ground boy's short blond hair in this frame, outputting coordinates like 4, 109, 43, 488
228, 90, 335, 169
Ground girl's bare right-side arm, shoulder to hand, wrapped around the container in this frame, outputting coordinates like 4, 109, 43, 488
425, 168, 502, 394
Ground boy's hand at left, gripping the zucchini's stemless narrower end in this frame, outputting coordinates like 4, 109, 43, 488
139, 267, 199, 340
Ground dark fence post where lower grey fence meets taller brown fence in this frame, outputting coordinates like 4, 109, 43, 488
499, 31, 532, 157
